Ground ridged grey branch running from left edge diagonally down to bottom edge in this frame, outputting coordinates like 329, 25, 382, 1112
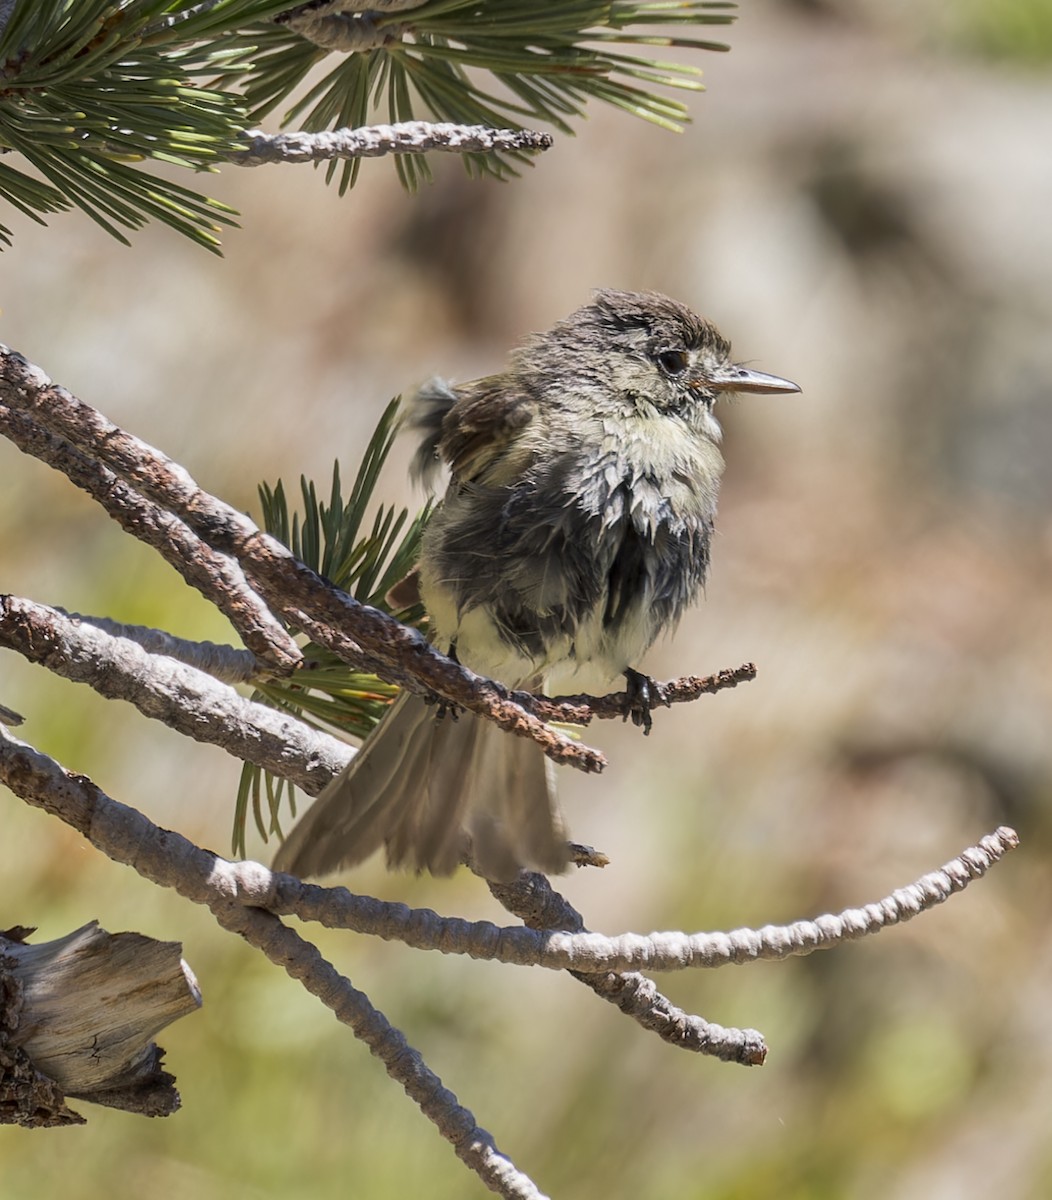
0, 727, 543, 1200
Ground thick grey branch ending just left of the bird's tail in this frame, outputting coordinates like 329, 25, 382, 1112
0, 595, 354, 796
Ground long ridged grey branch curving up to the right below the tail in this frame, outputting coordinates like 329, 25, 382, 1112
0, 727, 1018, 973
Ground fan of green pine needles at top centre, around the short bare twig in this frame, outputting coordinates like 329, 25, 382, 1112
218, 0, 735, 190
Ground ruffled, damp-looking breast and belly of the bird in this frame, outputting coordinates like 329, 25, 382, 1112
422, 428, 722, 682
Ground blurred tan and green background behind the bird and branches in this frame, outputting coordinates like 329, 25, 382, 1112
0, 0, 1052, 1200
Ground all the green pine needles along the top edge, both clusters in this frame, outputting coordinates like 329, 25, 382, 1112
0, 0, 734, 252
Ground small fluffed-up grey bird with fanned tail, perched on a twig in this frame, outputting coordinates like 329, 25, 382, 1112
273, 292, 800, 880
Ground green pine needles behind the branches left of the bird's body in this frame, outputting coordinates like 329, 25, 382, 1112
233, 398, 431, 856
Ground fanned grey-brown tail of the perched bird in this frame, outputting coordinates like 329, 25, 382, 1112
273, 692, 569, 881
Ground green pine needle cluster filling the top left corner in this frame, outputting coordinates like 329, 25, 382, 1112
0, 0, 247, 250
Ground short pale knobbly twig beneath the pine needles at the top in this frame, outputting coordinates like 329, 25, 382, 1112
226, 121, 554, 167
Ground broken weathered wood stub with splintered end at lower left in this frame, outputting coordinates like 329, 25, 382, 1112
0, 922, 202, 1126
